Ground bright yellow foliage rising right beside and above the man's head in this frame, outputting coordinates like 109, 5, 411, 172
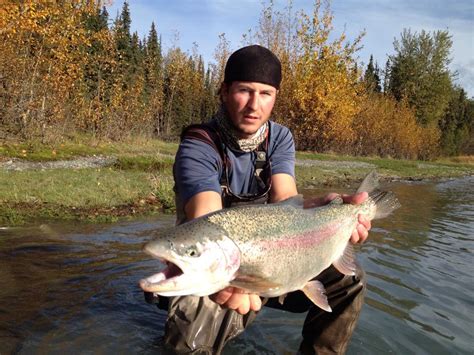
257, 0, 364, 151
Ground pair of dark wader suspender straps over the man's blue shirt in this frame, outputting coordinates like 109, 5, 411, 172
181, 123, 271, 204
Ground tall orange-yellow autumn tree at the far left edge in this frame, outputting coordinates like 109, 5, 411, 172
0, 0, 99, 140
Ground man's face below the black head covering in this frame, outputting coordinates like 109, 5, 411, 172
221, 81, 277, 138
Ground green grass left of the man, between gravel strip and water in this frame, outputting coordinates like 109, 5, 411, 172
0, 168, 174, 225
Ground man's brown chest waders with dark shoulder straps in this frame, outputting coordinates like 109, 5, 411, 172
145, 125, 365, 354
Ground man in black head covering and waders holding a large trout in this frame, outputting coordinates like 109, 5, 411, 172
152, 45, 370, 354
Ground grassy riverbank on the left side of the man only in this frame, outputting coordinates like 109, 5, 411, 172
0, 137, 177, 225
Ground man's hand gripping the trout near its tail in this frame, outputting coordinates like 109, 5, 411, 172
304, 192, 372, 244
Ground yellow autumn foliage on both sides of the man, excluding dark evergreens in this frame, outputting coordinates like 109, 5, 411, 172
0, 0, 448, 159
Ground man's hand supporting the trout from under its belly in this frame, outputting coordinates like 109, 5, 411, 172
209, 287, 262, 314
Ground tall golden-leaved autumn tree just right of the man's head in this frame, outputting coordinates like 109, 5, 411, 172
287, 1, 362, 151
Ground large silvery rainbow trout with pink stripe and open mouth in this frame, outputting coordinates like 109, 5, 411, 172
140, 173, 400, 312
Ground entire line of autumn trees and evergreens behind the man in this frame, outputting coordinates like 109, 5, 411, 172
0, 0, 474, 159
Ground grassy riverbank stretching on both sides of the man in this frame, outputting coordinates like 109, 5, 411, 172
0, 137, 474, 225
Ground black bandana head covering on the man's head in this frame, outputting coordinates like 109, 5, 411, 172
224, 45, 281, 89
